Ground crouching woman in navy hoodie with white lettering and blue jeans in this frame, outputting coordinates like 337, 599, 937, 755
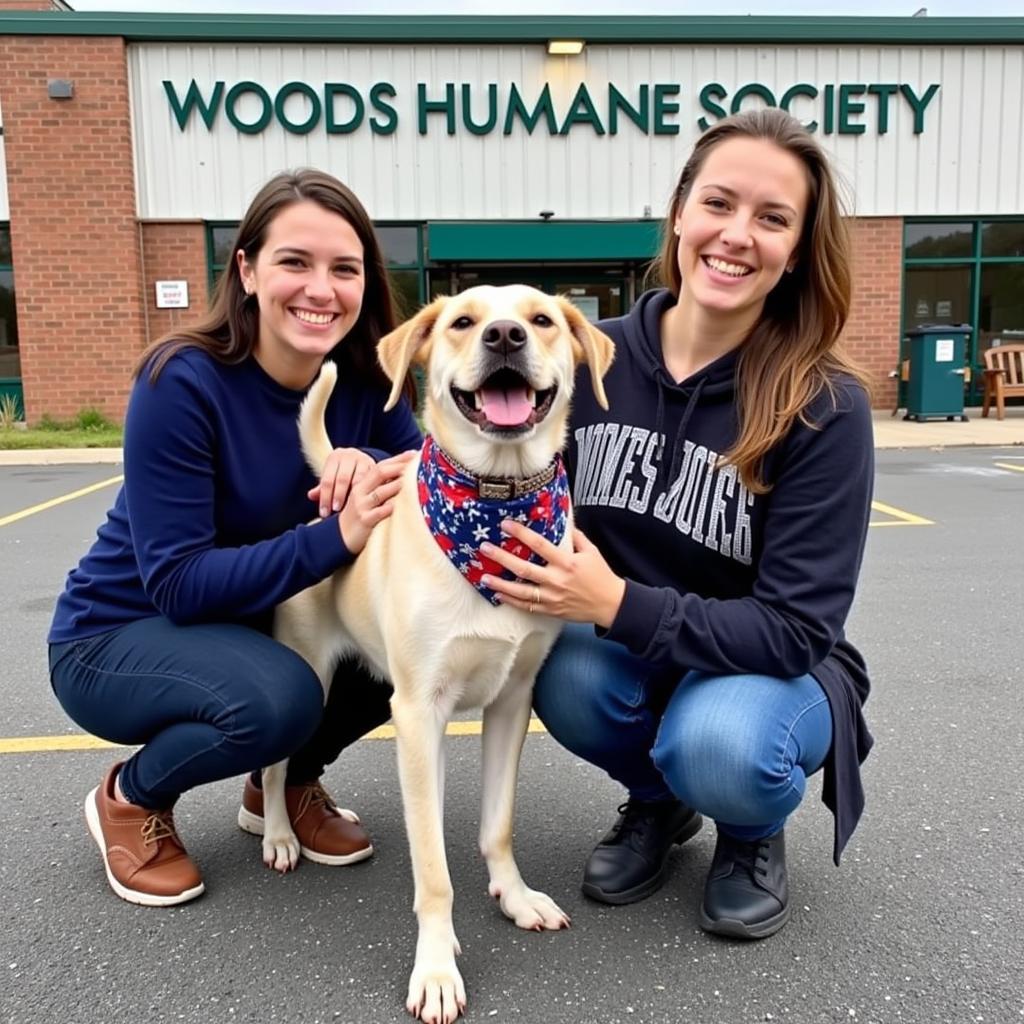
479, 110, 873, 938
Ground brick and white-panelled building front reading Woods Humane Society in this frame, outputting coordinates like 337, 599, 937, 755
0, 0, 1024, 422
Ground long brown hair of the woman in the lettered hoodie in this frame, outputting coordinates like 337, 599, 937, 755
655, 108, 870, 494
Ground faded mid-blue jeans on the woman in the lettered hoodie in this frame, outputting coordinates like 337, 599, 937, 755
534, 624, 831, 840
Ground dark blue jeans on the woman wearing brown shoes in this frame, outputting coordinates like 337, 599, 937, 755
50, 616, 391, 808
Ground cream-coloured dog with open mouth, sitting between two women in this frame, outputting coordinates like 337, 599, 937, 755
263, 285, 613, 1024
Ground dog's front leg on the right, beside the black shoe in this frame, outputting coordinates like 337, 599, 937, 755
480, 679, 569, 932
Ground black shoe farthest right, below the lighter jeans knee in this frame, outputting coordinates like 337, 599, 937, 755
700, 828, 790, 939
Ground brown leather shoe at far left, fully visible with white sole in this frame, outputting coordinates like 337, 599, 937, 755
85, 762, 204, 906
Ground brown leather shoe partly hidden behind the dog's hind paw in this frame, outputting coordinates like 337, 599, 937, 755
239, 776, 374, 865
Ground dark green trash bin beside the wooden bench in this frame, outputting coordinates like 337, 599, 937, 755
903, 324, 971, 423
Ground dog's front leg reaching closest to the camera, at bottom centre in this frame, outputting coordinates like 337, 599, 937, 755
391, 681, 466, 1024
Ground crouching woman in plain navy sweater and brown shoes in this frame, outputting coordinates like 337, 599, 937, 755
49, 170, 421, 906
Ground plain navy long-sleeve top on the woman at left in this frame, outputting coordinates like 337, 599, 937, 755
49, 347, 421, 643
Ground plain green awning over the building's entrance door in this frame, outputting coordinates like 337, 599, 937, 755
427, 220, 662, 263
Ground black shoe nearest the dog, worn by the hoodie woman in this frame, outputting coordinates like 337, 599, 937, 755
583, 800, 701, 904
